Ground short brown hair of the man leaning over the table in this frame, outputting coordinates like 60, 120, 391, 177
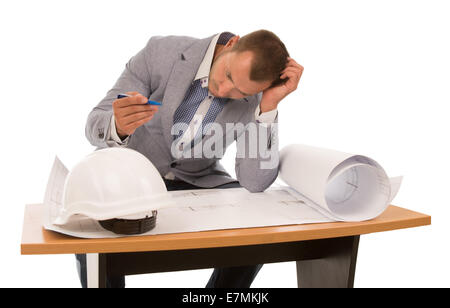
231, 30, 289, 87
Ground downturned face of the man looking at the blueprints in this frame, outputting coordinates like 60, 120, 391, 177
208, 48, 271, 99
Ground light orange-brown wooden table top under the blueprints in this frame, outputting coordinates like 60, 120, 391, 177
21, 204, 431, 255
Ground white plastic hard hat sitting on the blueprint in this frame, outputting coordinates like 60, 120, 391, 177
53, 147, 172, 231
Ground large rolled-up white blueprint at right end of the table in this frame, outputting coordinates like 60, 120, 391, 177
279, 144, 402, 221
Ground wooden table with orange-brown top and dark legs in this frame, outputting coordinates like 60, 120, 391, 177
21, 204, 431, 287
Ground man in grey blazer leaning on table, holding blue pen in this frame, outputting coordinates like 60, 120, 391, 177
77, 30, 303, 287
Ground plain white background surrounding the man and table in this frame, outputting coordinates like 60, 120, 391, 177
0, 0, 450, 287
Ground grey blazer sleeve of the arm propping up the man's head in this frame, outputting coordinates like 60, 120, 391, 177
235, 95, 279, 192
